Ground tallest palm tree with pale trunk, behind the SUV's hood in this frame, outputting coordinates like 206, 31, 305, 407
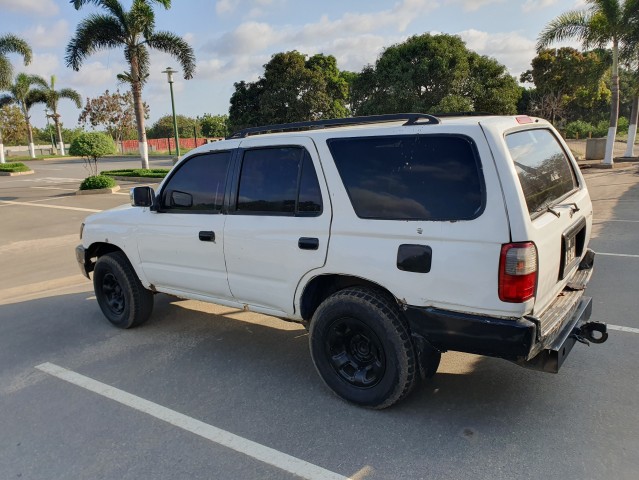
66, 0, 195, 168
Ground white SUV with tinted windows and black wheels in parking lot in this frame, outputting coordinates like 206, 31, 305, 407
76, 114, 607, 408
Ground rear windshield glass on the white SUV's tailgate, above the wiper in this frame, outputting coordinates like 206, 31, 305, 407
506, 129, 578, 216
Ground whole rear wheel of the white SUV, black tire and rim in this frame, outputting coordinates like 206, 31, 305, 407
309, 287, 417, 409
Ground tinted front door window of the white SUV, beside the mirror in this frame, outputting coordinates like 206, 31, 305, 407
160, 152, 231, 213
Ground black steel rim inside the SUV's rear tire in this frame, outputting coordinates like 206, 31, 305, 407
326, 317, 386, 388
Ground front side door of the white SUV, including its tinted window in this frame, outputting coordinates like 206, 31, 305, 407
138, 151, 233, 299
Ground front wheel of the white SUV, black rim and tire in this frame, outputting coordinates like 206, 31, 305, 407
93, 252, 153, 328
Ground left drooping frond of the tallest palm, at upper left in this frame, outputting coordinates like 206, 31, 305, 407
65, 15, 126, 71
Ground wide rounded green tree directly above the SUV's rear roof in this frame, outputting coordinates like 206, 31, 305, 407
351, 34, 521, 115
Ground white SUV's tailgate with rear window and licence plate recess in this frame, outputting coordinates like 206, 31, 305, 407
504, 128, 592, 314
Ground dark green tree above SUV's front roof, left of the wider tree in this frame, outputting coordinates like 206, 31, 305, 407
229, 51, 348, 131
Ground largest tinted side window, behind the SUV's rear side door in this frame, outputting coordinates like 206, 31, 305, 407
328, 135, 484, 220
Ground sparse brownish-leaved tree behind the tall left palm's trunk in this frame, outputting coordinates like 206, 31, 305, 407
78, 90, 149, 143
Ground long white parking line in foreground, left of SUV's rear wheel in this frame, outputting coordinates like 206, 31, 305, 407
35, 363, 348, 480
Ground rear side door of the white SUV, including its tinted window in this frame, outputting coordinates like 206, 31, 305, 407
224, 136, 331, 315
